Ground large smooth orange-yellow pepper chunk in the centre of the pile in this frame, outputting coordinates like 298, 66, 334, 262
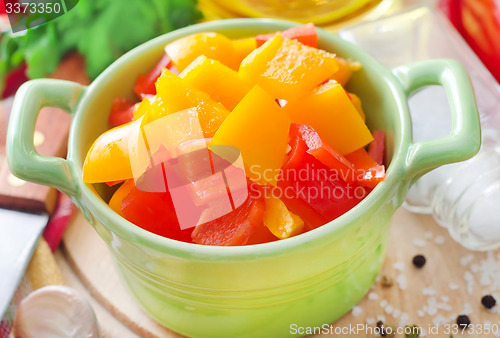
210, 86, 290, 185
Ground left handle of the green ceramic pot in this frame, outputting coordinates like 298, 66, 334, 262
6, 79, 85, 196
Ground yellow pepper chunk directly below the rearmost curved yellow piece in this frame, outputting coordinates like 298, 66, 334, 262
180, 55, 250, 110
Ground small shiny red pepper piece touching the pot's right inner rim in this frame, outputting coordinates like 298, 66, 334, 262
345, 148, 385, 188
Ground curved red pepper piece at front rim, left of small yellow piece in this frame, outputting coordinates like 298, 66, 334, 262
191, 187, 266, 246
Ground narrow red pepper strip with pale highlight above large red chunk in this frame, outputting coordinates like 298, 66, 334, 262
290, 124, 355, 183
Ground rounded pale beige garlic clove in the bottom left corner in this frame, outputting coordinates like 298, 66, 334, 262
13, 285, 99, 338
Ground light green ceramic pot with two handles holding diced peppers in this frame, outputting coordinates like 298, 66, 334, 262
7, 19, 480, 337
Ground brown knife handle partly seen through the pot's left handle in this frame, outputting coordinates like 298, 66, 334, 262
0, 107, 71, 213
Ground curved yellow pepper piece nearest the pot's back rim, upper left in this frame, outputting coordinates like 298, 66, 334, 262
165, 32, 240, 71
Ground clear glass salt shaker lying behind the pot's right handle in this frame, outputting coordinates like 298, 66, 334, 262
339, 6, 500, 250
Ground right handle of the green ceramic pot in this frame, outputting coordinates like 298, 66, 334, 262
392, 59, 481, 182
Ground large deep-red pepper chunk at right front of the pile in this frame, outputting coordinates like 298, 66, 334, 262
275, 129, 366, 229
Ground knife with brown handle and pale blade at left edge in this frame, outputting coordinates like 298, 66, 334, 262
0, 107, 71, 318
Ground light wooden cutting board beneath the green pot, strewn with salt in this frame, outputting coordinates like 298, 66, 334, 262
57, 208, 500, 337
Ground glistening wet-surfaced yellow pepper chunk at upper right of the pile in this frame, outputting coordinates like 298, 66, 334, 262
239, 34, 338, 100
